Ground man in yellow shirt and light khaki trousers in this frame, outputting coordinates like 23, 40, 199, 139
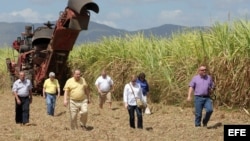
63, 69, 90, 130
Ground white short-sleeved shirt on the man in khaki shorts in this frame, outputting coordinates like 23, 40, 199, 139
95, 75, 114, 92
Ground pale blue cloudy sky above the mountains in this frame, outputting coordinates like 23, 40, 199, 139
0, 0, 250, 31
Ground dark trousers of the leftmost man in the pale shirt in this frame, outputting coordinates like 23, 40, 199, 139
15, 96, 30, 124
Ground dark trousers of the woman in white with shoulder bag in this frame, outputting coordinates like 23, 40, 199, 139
128, 105, 143, 129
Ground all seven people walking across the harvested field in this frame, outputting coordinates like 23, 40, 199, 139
12, 66, 214, 130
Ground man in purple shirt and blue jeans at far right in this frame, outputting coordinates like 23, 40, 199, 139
187, 66, 214, 127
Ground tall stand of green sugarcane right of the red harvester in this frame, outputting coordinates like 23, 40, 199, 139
1, 20, 250, 107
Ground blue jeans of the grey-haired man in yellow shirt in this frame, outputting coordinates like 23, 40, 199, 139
46, 93, 56, 116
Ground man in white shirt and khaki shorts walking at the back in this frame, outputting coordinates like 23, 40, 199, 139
95, 70, 114, 109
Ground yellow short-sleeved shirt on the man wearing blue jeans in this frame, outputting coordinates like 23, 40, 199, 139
43, 78, 60, 94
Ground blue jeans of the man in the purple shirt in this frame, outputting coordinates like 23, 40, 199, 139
194, 96, 213, 127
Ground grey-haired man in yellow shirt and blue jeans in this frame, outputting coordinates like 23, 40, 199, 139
43, 72, 60, 116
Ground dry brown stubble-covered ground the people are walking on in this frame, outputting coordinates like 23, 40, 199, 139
0, 92, 250, 141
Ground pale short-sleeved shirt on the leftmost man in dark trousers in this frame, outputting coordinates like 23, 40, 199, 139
12, 79, 32, 97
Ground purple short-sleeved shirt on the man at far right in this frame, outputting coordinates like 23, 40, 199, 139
189, 75, 214, 95
